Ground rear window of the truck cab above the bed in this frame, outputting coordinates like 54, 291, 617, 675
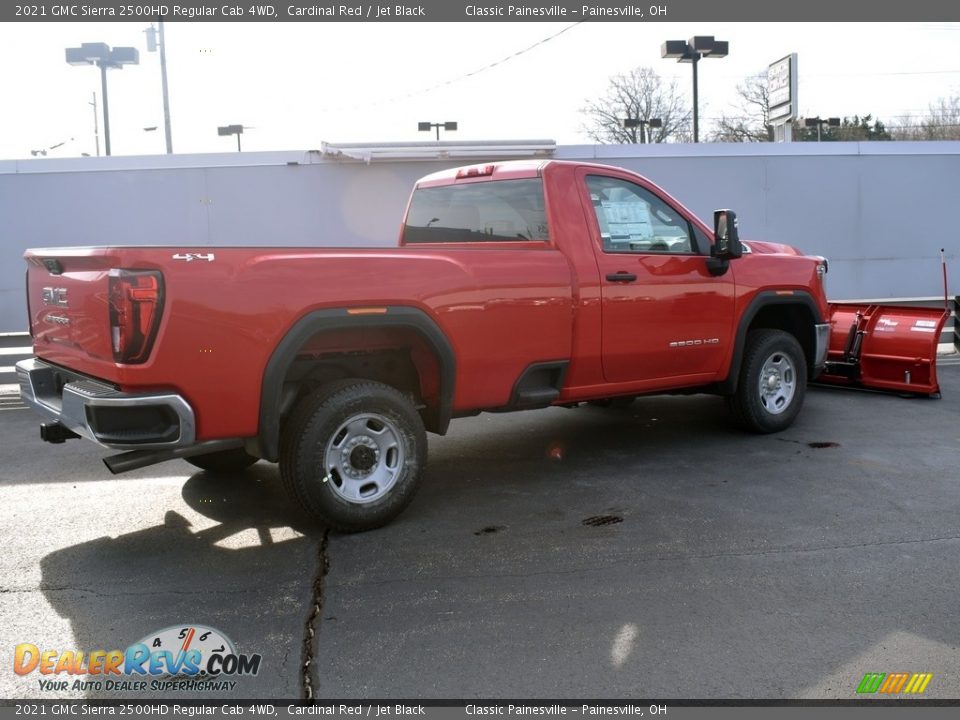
403, 177, 550, 245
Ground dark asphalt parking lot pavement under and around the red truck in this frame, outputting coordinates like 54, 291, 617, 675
0, 360, 960, 701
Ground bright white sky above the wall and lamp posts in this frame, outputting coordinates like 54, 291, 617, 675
0, 22, 960, 159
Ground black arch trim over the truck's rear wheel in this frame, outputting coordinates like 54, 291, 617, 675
256, 306, 456, 462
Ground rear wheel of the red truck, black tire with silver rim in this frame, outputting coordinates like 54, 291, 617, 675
280, 380, 427, 532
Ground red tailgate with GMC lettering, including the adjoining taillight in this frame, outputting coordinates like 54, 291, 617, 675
24, 248, 163, 373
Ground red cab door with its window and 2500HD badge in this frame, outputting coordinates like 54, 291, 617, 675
578, 168, 735, 385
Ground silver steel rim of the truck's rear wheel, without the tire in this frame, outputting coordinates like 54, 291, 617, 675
323, 413, 405, 505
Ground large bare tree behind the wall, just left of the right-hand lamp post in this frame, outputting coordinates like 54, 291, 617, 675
580, 67, 691, 144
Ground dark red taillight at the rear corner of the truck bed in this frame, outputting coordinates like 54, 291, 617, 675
109, 270, 163, 364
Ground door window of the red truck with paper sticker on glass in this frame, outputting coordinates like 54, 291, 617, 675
587, 175, 697, 255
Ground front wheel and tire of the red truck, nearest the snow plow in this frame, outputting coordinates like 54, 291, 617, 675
729, 330, 807, 433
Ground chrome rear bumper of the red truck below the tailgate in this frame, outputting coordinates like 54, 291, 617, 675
16, 358, 197, 450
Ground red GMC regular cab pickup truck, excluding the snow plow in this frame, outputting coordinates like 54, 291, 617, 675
17, 160, 940, 531
